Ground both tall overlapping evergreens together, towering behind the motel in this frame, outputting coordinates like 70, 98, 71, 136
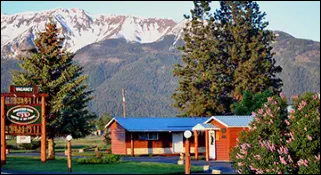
172, 1, 282, 116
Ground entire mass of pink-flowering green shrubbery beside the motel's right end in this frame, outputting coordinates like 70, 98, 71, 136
231, 93, 320, 174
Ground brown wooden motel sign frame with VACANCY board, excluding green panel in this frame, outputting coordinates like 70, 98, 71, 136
1, 86, 48, 165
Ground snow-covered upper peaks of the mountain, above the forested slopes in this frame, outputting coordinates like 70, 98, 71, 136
1, 8, 184, 58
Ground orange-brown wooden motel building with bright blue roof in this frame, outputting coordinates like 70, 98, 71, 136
105, 116, 253, 161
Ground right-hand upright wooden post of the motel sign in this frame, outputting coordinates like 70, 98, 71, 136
41, 96, 46, 163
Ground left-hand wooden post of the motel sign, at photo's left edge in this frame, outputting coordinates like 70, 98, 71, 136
1, 96, 7, 165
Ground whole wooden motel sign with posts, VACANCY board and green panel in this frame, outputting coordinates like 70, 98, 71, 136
1, 86, 48, 164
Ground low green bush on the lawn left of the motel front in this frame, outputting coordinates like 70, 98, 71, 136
77, 154, 120, 164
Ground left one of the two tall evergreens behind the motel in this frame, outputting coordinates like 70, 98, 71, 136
172, 1, 230, 116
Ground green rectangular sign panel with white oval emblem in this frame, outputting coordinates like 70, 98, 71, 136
6, 105, 41, 125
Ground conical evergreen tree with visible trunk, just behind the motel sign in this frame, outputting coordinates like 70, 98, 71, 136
12, 20, 96, 159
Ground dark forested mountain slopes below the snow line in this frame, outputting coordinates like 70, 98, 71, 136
1, 31, 320, 116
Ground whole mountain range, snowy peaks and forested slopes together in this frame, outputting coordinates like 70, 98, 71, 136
1, 8, 320, 116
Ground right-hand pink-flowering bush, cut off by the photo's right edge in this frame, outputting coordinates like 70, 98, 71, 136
287, 93, 320, 174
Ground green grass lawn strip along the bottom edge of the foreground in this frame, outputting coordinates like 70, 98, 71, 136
2, 156, 203, 174
